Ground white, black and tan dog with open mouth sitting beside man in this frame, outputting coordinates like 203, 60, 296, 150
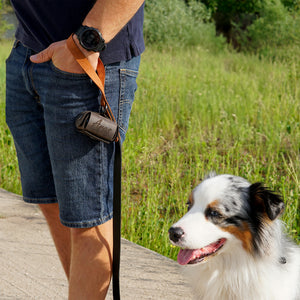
169, 174, 300, 300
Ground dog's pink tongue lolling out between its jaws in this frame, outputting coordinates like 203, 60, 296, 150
177, 240, 223, 265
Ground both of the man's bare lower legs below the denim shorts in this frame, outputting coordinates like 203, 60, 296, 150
40, 204, 113, 300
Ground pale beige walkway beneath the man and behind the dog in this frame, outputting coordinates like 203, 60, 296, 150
0, 189, 192, 300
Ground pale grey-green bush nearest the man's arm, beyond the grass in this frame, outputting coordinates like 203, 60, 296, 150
144, 0, 224, 49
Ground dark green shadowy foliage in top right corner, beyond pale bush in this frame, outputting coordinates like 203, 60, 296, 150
195, 0, 300, 51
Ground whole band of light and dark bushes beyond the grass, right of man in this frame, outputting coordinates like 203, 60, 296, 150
144, 0, 300, 59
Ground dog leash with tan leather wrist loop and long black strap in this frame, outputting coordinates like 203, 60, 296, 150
67, 35, 122, 300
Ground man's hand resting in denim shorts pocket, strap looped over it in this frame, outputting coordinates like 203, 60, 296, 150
30, 37, 99, 74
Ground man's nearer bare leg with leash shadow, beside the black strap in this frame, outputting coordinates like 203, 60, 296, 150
69, 220, 113, 300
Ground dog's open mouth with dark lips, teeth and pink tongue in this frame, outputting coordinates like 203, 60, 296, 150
177, 238, 226, 265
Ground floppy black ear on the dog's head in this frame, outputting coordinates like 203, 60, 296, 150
249, 182, 284, 221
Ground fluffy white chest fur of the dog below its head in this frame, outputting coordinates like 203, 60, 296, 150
182, 248, 300, 300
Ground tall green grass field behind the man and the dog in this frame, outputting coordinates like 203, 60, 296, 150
0, 40, 300, 258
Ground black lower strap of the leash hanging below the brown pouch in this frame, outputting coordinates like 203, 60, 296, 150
112, 140, 122, 300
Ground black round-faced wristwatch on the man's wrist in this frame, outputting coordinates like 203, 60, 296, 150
75, 25, 106, 52
